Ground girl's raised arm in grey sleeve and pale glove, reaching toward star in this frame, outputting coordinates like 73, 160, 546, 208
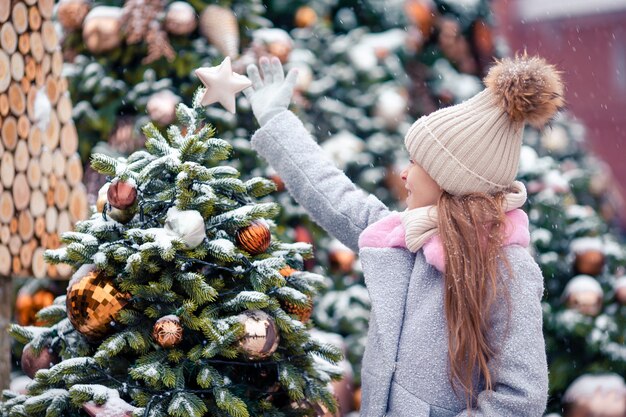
244, 58, 388, 251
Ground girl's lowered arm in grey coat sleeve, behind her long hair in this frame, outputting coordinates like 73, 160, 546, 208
457, 246, 548, 417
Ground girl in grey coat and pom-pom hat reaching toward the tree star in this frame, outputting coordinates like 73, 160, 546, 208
244, 55, 563, 417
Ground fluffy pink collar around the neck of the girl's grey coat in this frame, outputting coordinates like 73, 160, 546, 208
359, 209, 530, 272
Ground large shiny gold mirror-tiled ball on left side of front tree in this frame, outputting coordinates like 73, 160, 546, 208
66, 271, 130, 340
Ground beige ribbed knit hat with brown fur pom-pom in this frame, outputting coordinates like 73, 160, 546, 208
404, 54, 564, 195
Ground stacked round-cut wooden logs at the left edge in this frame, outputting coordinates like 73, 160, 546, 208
0, 0, 88, 278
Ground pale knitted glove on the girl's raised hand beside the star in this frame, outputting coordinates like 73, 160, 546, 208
243, 57, 298, 126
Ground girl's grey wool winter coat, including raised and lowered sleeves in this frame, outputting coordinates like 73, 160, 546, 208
252, 111, 548, 417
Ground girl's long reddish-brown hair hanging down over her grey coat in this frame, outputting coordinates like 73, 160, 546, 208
438, 191, 510, 409
